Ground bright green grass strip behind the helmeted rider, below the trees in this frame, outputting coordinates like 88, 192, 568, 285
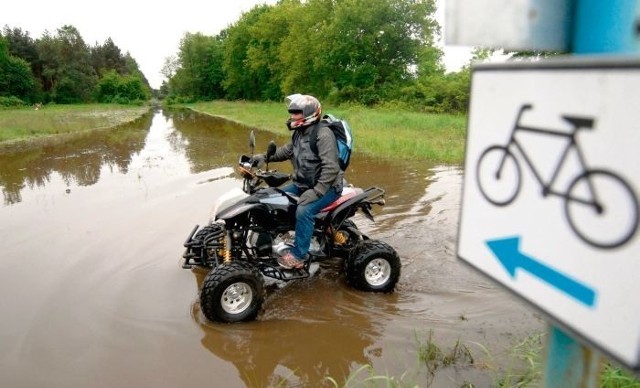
186, 101, 466, 164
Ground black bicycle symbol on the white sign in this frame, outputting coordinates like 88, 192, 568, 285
476, 104, 639, 249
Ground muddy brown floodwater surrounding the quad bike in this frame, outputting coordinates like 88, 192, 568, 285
0, 111, 543, 387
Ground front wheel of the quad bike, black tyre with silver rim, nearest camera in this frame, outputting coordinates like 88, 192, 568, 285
200, 262, 264, 323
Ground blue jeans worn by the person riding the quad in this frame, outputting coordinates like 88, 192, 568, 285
282, 183, 340, 259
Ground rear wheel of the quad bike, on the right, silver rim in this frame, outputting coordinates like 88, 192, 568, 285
345, 240, 401, 292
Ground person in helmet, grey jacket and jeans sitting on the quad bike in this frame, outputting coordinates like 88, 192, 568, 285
254, 94, 344, 269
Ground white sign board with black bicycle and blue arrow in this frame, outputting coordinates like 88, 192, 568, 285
458, 58, 640, 368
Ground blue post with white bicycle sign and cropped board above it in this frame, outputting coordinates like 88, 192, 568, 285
446, 0, 640, 387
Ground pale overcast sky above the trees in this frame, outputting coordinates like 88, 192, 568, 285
0, 0, 469, 88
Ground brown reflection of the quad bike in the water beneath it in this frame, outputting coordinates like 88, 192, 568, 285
192, 263, 399, 387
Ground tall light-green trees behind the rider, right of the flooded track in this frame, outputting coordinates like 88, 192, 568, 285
160, 0, 476, 113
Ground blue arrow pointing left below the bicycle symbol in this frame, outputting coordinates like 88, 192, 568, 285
487, 236, 596, 307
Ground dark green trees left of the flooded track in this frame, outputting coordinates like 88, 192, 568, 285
0, 25, 152, 106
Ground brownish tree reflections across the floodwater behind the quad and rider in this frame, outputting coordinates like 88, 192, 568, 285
0, 106, 432, 212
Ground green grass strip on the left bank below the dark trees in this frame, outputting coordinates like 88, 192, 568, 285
0, 104, 149, 144
